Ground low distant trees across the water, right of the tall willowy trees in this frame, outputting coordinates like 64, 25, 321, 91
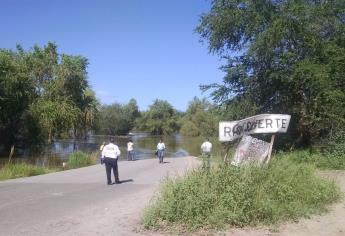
94, 97, 219, 136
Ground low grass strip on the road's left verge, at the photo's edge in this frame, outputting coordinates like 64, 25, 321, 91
0, 163, 50, 180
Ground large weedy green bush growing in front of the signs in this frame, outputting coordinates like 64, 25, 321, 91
142, 158, 340, 230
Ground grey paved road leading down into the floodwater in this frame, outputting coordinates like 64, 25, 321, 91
0, 157, 197, 236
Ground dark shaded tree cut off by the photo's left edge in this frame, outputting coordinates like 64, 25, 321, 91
0, 49, 35, 150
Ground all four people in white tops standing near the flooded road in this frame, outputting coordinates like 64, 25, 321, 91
100, 138, 212, 185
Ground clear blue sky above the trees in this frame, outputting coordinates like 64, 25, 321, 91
0, 0, 224, 111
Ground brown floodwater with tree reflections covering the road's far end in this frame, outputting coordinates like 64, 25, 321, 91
0, 133, 223, 167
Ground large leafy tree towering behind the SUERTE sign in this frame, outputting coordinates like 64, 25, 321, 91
196, 0, 345, 145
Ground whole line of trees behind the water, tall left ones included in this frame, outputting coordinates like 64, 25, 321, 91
0, 43, 218, 154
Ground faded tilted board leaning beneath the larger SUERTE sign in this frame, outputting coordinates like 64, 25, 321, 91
231, 136, 270, 166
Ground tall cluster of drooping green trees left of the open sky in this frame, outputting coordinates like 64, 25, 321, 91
0, 43, 98, 153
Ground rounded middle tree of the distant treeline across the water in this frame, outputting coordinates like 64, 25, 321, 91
136, 99, 178, 135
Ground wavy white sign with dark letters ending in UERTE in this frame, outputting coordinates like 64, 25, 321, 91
219, 114, 291, 142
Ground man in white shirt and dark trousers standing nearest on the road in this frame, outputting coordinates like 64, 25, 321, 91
102, 138, 121, 185
